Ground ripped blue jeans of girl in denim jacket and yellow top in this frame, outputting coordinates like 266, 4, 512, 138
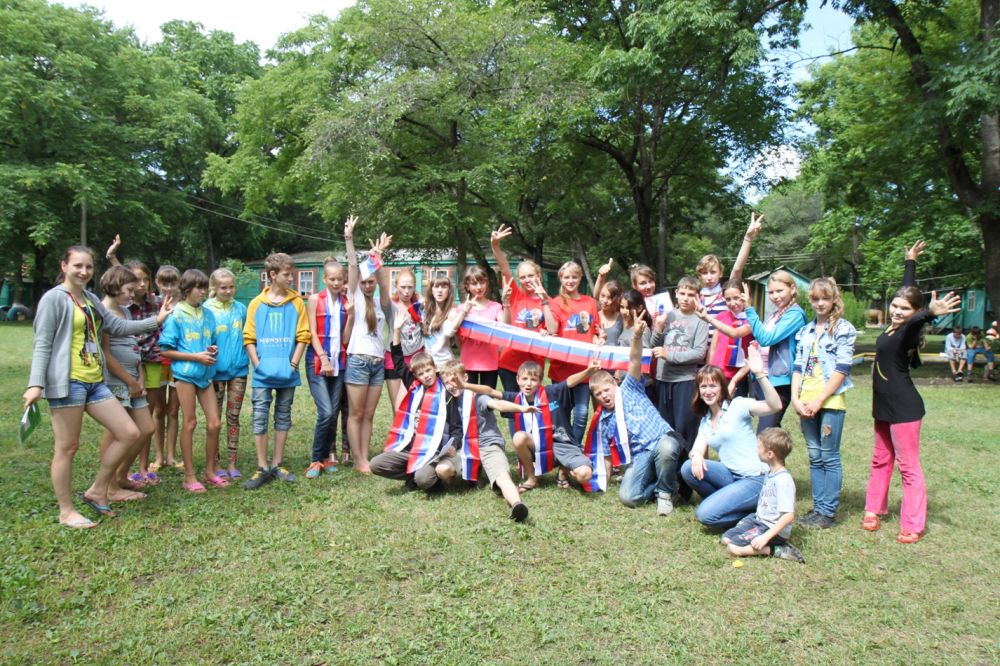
799, 409, 847, 518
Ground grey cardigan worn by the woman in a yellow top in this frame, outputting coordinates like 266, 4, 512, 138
28, 284, 158, 400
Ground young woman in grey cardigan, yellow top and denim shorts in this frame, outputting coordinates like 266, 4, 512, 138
24, 245, 171, 529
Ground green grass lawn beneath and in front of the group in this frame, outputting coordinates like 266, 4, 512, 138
0, 325, 1000, 664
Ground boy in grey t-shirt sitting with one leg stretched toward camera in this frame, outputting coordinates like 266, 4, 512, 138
435, 360, 537, 523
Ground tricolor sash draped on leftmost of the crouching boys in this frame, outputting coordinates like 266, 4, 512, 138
385, 379, 450, 474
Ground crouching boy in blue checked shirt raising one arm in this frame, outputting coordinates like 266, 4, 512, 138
588, 319, 683, 516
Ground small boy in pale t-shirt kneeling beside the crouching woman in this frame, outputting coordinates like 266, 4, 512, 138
722, 428, 805, 564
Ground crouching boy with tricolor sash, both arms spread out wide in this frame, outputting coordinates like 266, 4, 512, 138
466, 361, 599, 493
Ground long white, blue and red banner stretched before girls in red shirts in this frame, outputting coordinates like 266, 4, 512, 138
458, 317, 652, 373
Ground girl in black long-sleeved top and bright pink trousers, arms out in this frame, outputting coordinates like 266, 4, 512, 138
861, 241, 961, 543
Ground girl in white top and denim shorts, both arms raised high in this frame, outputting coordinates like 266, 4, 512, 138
344, 215, 392, 475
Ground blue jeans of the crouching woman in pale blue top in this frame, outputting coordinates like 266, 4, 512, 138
681, 460, 766, 528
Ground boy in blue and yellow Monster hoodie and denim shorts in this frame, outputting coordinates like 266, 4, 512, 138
243, 252, 312, 490
